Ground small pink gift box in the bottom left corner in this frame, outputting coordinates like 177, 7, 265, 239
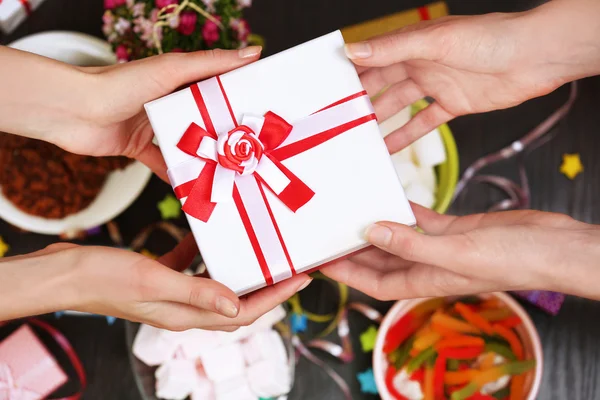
0, 325, 68, 400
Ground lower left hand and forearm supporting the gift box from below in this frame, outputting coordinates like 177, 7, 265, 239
0, 235, 310, 331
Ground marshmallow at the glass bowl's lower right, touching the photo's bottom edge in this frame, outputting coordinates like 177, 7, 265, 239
247, 359, 292, 398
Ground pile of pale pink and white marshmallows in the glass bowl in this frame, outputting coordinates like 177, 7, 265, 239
133, 306, 292, 400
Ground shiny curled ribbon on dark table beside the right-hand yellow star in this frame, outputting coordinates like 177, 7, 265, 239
452, 82, 578, 211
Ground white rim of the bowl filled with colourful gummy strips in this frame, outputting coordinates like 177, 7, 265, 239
373, 292, 544, 400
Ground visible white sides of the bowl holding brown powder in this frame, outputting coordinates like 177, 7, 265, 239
0, 32, 152, 235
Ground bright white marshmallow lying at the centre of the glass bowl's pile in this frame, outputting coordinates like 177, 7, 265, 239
200, 342, 246, 383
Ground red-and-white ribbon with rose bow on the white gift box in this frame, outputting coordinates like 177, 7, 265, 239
169, 77, 376, 285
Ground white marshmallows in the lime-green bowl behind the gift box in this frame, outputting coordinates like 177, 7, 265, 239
379, 107, 446, 208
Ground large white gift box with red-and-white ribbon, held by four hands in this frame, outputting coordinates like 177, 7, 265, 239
146, 32, 415, 295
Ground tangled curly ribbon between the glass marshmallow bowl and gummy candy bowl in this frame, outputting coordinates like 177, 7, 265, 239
289, 273, 383, 400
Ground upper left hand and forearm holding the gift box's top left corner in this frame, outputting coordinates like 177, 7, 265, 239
0, 46, 262, 180
